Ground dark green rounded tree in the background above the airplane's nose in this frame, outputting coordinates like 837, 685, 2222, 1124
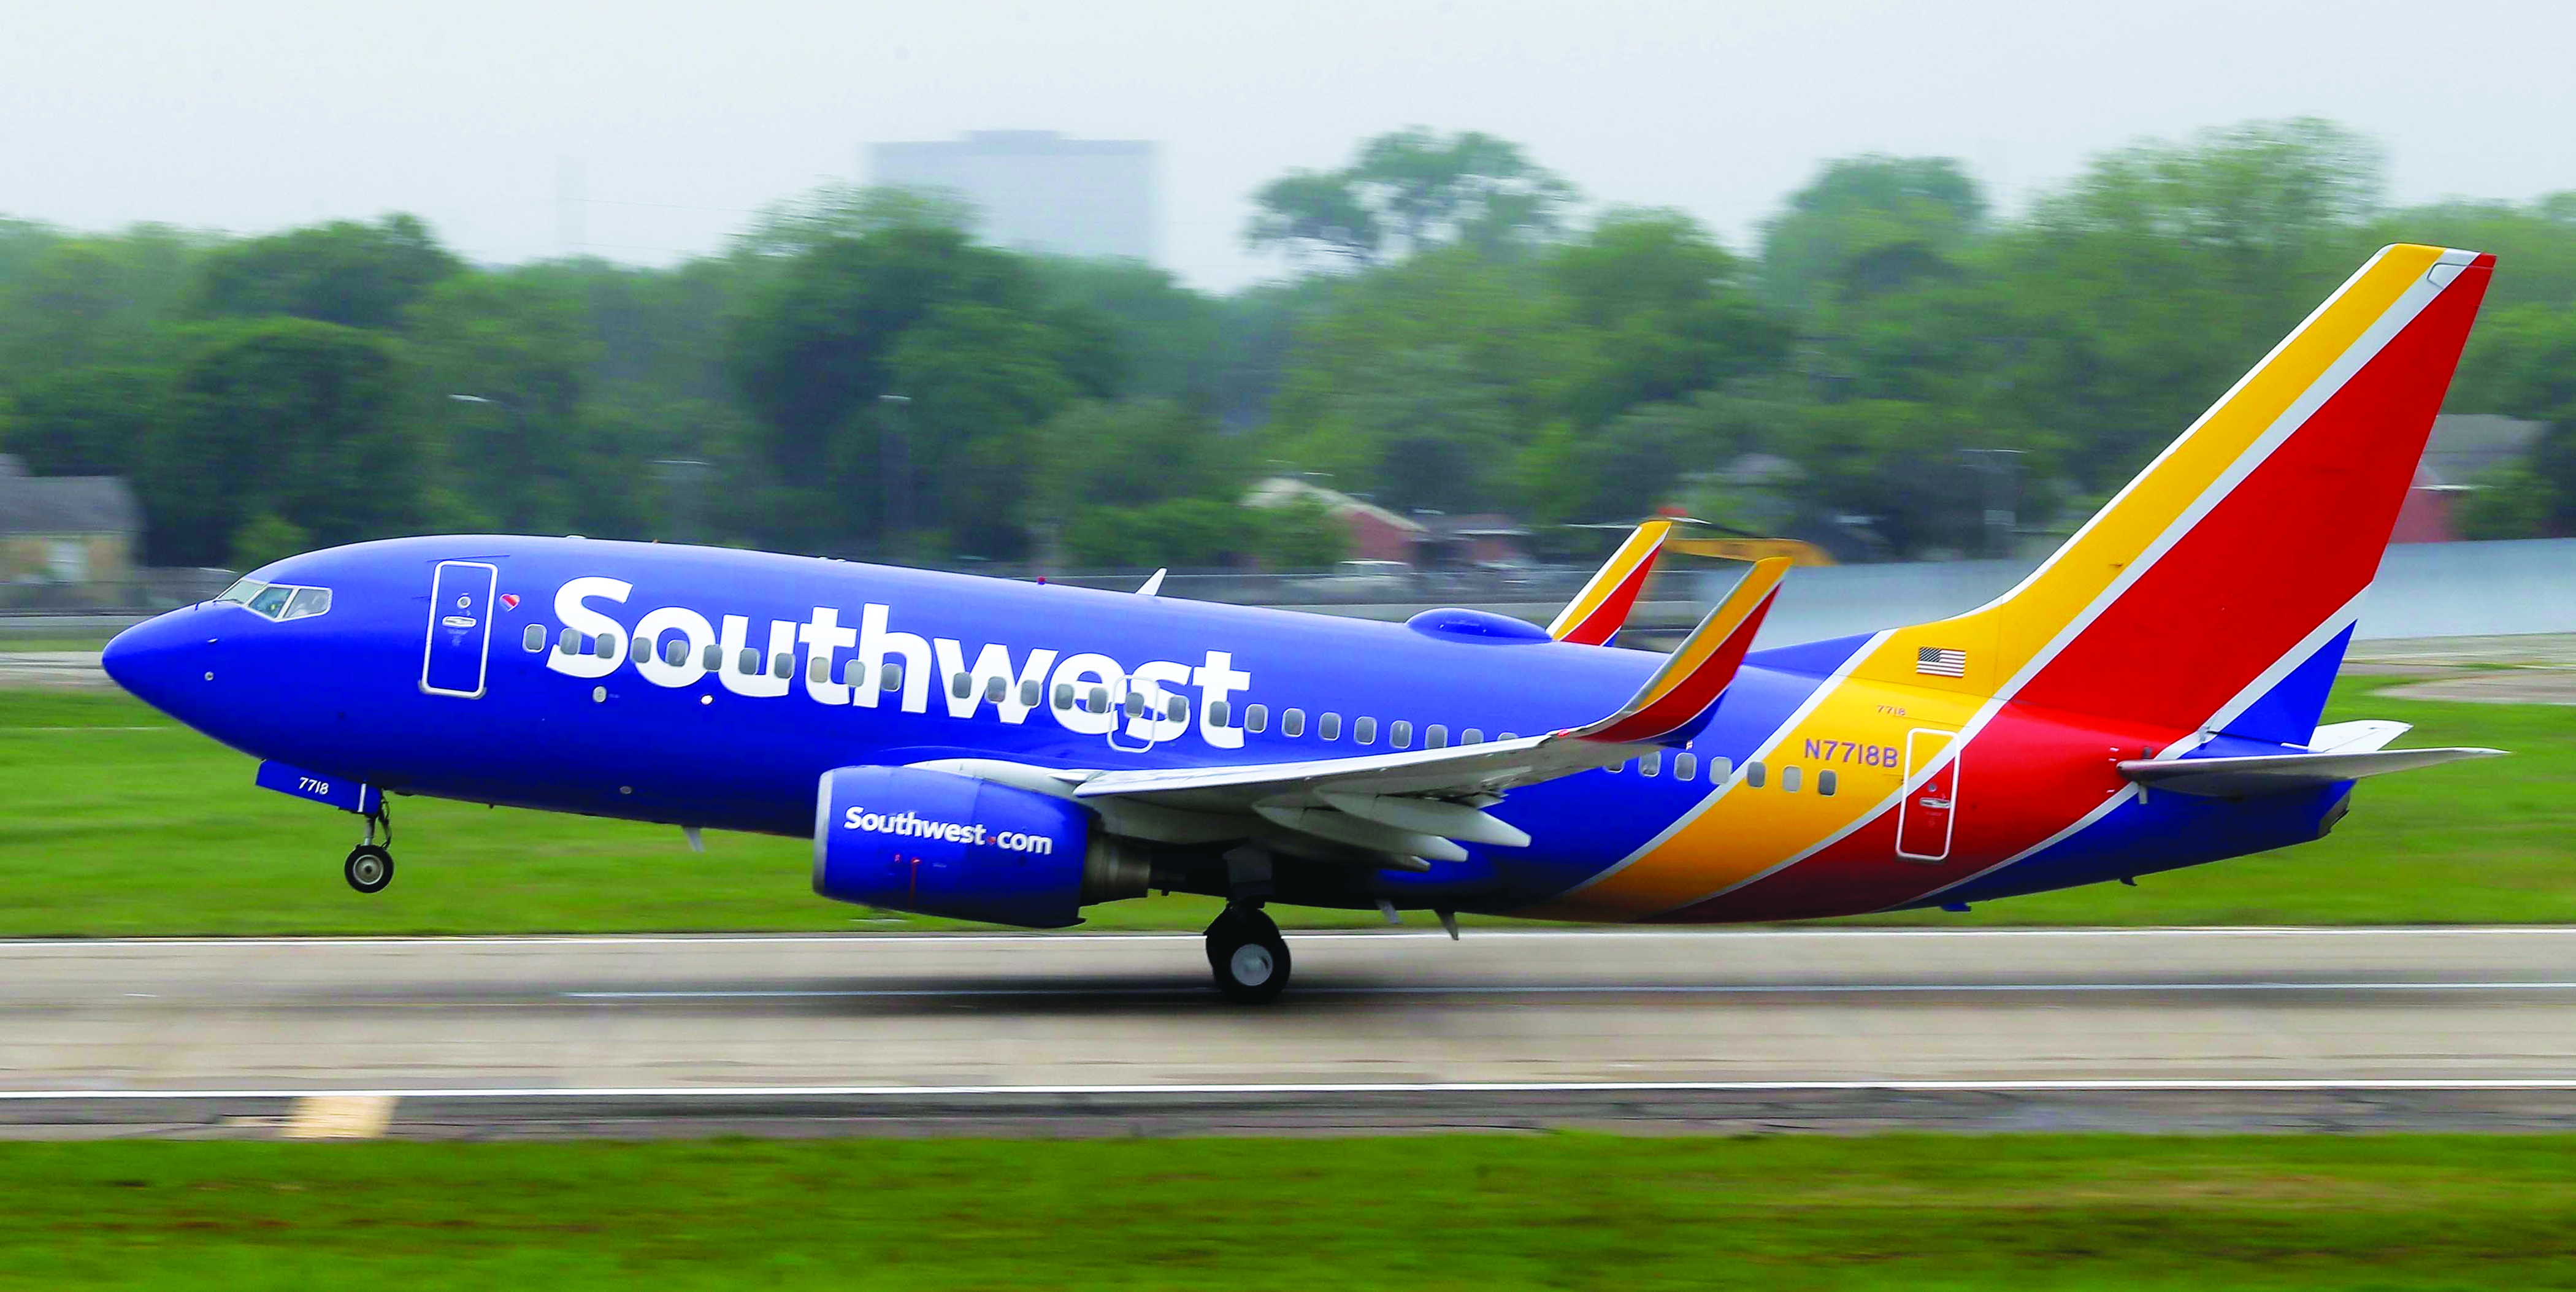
139, 319, 423, 564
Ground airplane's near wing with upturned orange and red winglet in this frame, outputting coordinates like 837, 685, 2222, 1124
1071, 559, 1788, 867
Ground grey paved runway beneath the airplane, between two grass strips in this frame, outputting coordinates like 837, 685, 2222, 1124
0, 929, 2576, 1135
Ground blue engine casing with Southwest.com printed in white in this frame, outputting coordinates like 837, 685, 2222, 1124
814, 767, 1151, 929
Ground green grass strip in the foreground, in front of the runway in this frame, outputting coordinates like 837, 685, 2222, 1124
0, 1135, 2576, 1292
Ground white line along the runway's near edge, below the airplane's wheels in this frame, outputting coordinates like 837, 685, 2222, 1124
0, 1076, 2576, 1109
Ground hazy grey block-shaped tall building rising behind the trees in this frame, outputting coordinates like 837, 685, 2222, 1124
868, 131, 1157, 260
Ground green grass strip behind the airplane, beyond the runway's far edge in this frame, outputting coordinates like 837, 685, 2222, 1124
0, 679, 2576, 937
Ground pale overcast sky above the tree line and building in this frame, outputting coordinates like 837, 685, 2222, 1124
0, 0, 2576, 288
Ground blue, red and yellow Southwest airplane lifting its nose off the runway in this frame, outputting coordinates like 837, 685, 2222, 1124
103, 245, 2496, 1001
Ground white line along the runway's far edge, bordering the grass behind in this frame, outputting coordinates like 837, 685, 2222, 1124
0, 924, 2576, 952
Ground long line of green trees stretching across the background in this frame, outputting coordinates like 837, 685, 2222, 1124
0, 121, 2576, 569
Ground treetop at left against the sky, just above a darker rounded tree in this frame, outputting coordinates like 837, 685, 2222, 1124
196, 216, 464, 329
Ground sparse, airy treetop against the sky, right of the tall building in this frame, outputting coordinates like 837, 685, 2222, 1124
1244, 126, 1574, 265
